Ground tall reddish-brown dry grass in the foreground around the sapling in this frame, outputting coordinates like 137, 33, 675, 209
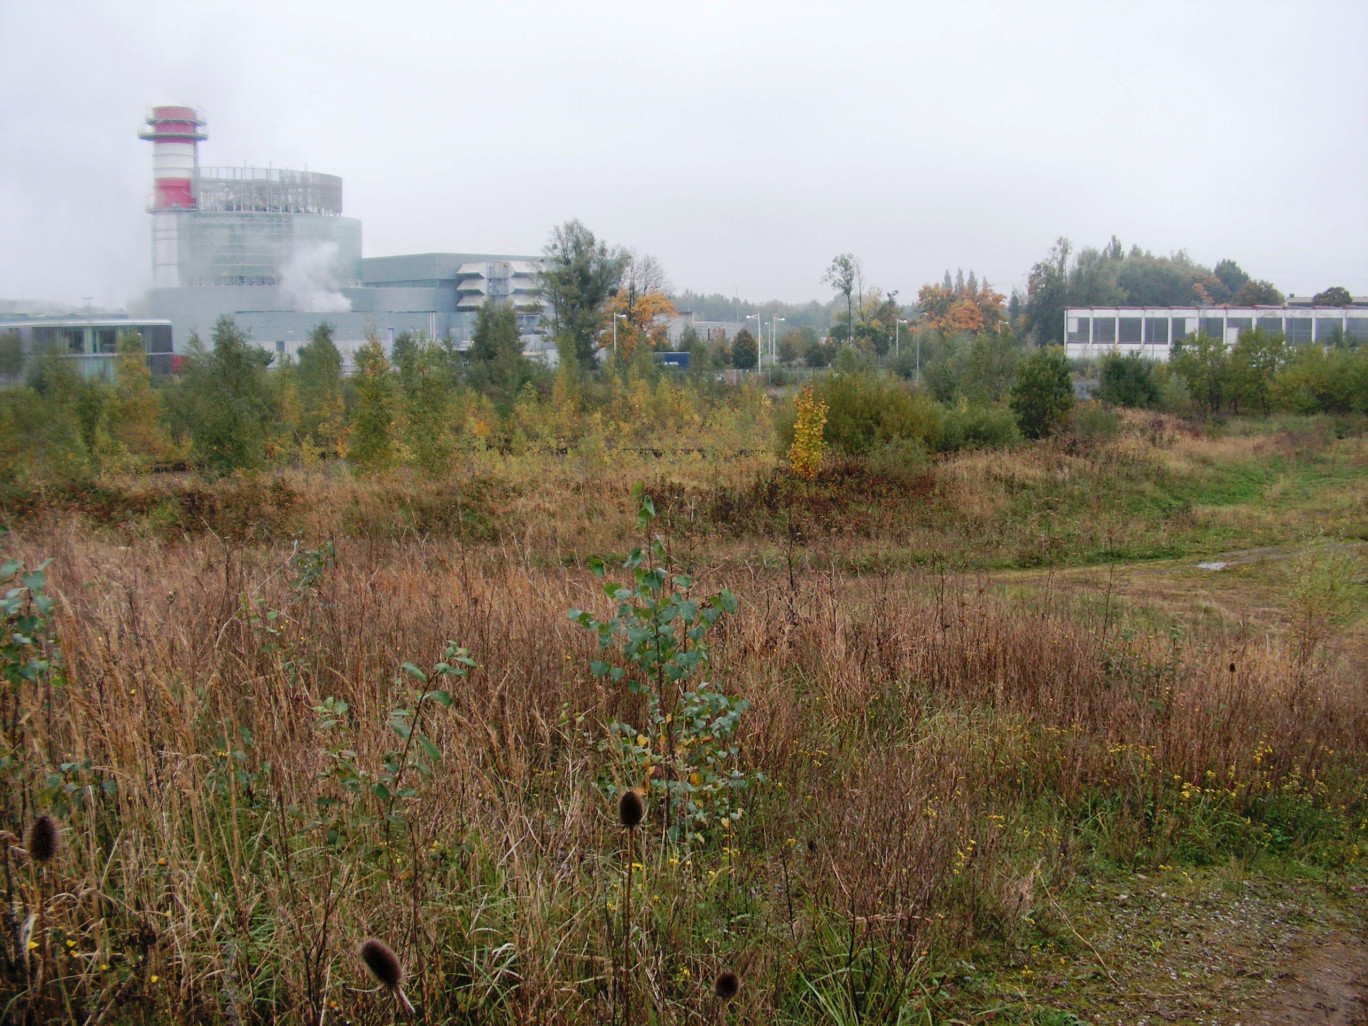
0, 511, 1368, 1023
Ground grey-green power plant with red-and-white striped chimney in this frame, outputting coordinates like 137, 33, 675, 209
137, 105, 547, 358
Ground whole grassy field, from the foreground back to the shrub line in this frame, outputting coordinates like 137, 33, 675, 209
0, 419, 1368, 1025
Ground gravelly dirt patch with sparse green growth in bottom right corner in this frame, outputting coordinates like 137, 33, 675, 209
1003, 870, 1368, 1026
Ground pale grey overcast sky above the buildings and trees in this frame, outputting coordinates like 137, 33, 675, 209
0, 0, 1368, 305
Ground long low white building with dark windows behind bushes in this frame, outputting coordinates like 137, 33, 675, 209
1064, 301, 1368, 361
